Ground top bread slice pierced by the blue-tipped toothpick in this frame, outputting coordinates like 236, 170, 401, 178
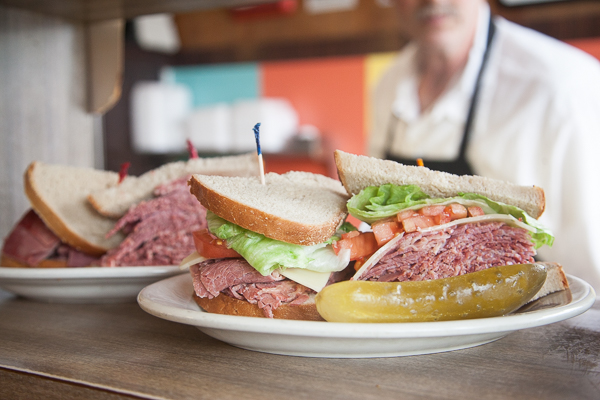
189, 171, 348, 246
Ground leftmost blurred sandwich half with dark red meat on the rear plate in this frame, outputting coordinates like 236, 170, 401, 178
1, 161, 123, 268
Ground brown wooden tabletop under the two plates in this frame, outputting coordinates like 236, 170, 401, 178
0, 291, 600, 400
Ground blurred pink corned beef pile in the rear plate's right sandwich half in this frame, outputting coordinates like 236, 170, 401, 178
100, 178, 206, 267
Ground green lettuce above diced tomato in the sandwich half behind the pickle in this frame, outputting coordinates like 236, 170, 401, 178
348, 184, 554, 248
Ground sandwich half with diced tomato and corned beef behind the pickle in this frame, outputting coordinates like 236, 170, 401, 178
334, 150, 568, 298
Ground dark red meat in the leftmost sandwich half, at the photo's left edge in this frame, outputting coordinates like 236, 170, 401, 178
2, 210, 98, 267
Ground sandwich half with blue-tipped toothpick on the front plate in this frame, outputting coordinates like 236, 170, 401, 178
182, 172, 353, 320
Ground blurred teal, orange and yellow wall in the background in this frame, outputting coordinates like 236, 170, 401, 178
163, 39, 600, 172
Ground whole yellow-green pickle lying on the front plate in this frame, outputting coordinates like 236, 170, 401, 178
316, 264, 546, 323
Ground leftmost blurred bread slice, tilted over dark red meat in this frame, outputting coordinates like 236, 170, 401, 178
24, 161, 123, 256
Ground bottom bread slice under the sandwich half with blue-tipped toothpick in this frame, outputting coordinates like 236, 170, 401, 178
193, 293, 324, 321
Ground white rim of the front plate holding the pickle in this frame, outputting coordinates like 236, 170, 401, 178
137, 274, 596, 339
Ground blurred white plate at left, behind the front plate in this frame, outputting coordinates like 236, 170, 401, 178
0, 266, 184, 304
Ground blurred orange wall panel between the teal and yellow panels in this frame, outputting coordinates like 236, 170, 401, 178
261, 57, 365, 154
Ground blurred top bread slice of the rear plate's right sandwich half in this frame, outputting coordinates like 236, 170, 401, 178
88, 153, 259, 218
